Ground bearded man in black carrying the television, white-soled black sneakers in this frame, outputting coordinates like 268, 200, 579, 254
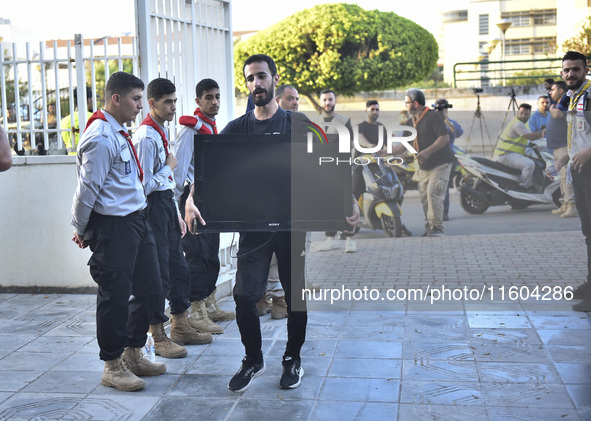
185, 54, 359, 392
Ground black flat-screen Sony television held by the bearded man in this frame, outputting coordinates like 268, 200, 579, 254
194, 135, 353, 232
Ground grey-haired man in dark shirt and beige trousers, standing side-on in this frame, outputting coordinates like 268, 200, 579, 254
392, 89, 454, 237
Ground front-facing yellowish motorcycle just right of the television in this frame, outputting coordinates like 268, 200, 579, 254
357, 154, 412, 237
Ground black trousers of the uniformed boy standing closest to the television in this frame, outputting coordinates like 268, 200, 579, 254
179, 186, 220, 301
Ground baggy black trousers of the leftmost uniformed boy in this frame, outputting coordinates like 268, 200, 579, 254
84, 212, 161, 361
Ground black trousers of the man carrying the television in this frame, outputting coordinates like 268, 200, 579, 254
234, 232, 308, 362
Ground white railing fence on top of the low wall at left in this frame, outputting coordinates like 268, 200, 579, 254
0, 34, 138, 155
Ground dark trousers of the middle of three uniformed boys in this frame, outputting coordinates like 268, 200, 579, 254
147, 190, 191, 325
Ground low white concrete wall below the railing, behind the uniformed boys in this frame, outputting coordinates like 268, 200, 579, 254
0, 156, 238, 295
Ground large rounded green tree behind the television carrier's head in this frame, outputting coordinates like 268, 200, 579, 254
234, 3, 438, 106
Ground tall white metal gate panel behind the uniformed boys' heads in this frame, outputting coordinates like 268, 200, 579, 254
136, 0, 234, 136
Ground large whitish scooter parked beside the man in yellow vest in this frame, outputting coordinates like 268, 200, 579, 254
456, 142, 561, 214
